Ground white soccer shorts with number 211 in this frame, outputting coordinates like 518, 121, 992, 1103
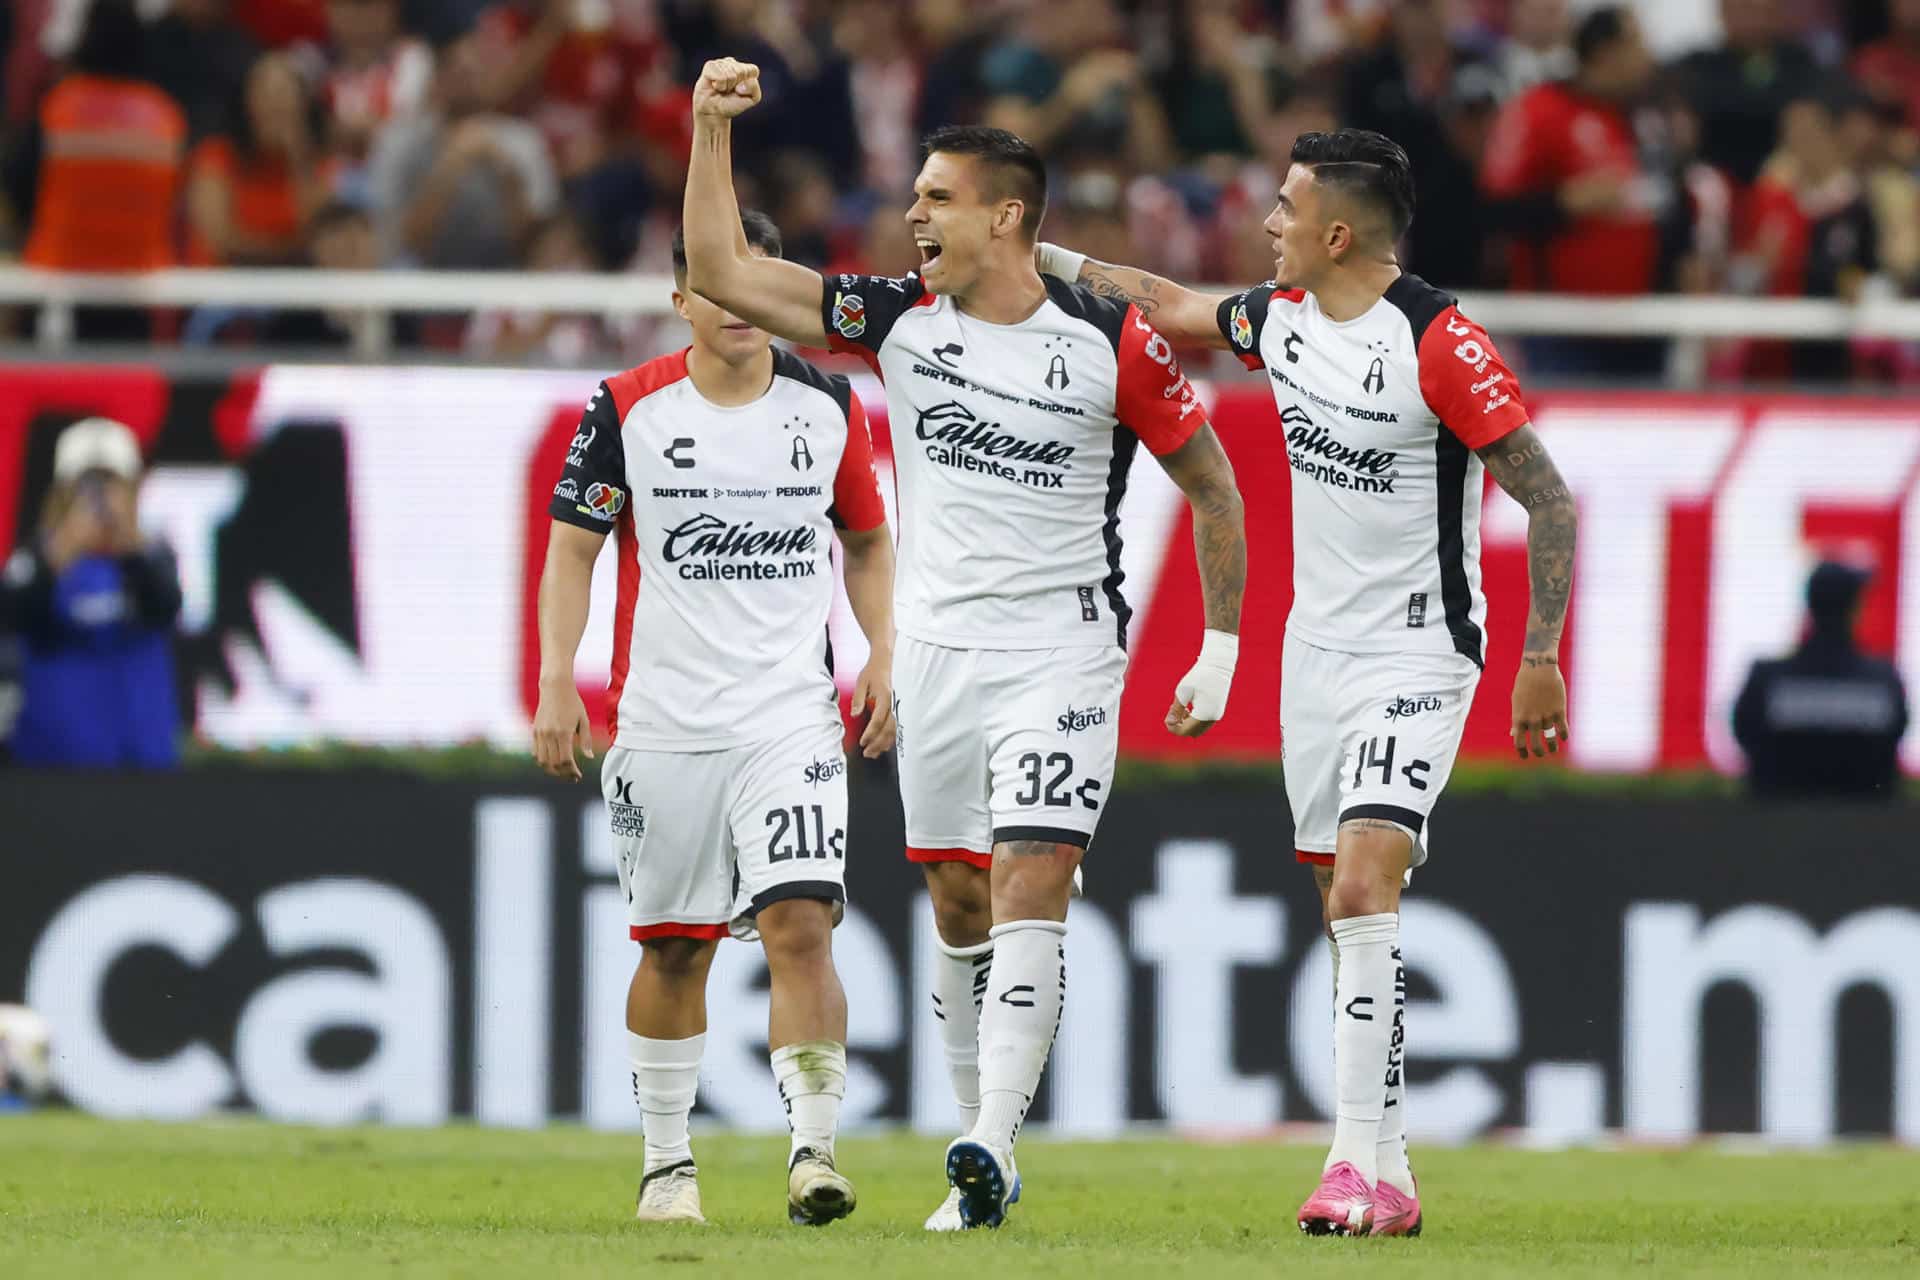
601, 723, 847, 942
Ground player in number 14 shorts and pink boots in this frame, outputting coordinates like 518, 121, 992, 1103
1039, 129, 1576, 1236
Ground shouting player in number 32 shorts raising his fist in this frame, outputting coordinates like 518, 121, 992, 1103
685, 59, 1246, 1230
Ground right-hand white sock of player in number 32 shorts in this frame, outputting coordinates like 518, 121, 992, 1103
972, 919, 1068, 1151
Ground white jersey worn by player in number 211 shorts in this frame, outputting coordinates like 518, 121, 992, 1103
549, 351, 887, 750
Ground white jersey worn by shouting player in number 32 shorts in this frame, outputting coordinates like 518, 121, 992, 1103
822, 274, 1206, 649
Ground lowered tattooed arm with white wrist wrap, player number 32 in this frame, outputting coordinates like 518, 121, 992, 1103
1160, 426, 1246, 737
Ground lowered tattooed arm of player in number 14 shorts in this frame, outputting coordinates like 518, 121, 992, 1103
1478, 426, 1580, 756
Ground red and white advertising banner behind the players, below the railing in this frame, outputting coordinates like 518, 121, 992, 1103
0, 365, 1920, 771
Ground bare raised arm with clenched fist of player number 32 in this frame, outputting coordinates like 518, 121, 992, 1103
682, 58, 828, 347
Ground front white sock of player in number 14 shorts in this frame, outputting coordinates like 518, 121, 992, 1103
1327, 913, 1405, 1182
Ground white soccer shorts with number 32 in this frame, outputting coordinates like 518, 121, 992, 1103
893, 635, 1127, 867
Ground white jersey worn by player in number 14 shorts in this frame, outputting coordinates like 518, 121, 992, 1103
1217, 274, 1526, 664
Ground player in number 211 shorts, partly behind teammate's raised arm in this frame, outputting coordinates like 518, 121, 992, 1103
534, 213, 893, 1226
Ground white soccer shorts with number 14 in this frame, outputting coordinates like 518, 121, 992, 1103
1281, 635, 1480, 867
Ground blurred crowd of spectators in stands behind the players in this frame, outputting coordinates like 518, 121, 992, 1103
0, 0, 1920, 378
